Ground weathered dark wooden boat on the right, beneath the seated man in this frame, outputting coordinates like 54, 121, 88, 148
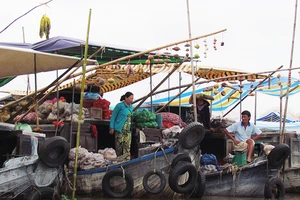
201, 125, 300, 198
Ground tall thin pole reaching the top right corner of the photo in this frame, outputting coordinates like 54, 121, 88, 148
280, 0, 298, 143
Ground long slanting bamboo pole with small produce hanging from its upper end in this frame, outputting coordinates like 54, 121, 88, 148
68, 29, 227, 78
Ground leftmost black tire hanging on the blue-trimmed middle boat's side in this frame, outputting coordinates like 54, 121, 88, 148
102, 168, 134, 198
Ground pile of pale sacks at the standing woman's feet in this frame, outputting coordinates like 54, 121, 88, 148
68, 147, 117, 170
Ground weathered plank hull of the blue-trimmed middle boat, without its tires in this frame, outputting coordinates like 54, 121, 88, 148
69, 148, 199, 199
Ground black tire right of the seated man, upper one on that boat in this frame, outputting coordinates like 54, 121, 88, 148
268, 144, 291, 169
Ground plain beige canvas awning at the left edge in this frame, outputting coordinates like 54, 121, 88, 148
0, 46, 96, 78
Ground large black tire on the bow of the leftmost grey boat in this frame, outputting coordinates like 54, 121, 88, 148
39, 136, 70, 167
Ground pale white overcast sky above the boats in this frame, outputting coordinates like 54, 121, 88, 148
0, 0, 300, 119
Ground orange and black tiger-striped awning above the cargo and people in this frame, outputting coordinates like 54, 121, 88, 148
59, 62, 266, 93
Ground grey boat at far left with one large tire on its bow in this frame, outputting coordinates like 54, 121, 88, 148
0, 130, 70, 200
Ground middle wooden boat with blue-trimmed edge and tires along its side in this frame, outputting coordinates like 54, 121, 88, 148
64, 122, 205, 199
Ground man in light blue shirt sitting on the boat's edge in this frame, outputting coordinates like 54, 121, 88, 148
222, 110, 262, 163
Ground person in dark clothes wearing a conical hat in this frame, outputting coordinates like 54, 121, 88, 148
187, 93, 214, 131
